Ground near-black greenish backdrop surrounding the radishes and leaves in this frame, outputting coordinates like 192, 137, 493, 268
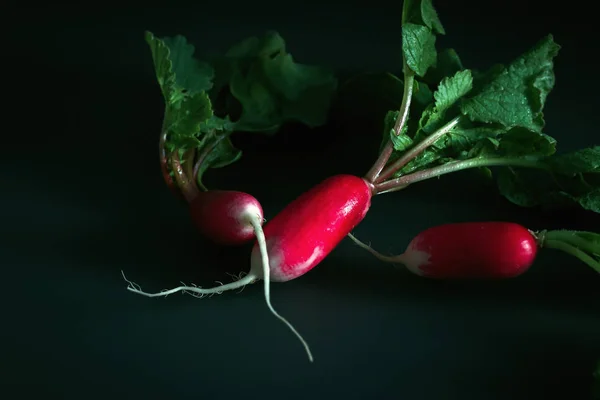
0, 0, 600, 400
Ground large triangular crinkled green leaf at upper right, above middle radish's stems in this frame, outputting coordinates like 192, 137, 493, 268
461, 35, 560, 133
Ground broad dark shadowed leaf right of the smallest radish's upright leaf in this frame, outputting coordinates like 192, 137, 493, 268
220, 32, 337, 133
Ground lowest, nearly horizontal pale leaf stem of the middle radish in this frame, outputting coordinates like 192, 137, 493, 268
374, 157, 548, 194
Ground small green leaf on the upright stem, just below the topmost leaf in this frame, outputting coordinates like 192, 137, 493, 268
402, 23, 437, 77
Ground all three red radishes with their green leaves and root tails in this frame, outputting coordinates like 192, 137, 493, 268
126, 0, 600, 361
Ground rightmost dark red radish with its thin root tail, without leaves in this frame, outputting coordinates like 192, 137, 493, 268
349, 222, 538, 279
